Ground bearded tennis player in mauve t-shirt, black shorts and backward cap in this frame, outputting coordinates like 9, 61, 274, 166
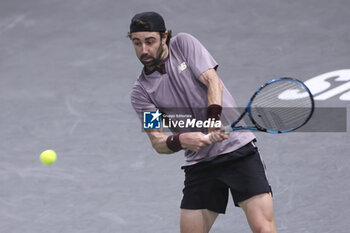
128, 12, 276, 233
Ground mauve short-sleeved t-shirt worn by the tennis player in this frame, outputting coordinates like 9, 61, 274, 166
131, 33, 255, 166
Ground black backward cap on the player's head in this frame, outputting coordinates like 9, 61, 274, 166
130, 12, 166, 33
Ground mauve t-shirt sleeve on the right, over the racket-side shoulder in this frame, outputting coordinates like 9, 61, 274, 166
177, 33, 218, 78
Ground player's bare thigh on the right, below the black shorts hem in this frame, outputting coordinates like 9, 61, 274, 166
239, 193, 276, 232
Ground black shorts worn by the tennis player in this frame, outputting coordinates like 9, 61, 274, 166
181, 143, 272, 213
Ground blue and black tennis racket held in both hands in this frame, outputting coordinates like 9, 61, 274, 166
206, 78, 315, 138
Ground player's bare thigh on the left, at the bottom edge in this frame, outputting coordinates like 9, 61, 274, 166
180, 209, 218, 233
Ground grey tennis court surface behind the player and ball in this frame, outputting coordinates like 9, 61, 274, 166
0, 0, 350, 233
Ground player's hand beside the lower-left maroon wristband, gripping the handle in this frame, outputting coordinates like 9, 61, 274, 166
180, 132, 212, 152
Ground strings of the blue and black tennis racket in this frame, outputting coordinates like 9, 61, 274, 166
251, 80, 312, 131
